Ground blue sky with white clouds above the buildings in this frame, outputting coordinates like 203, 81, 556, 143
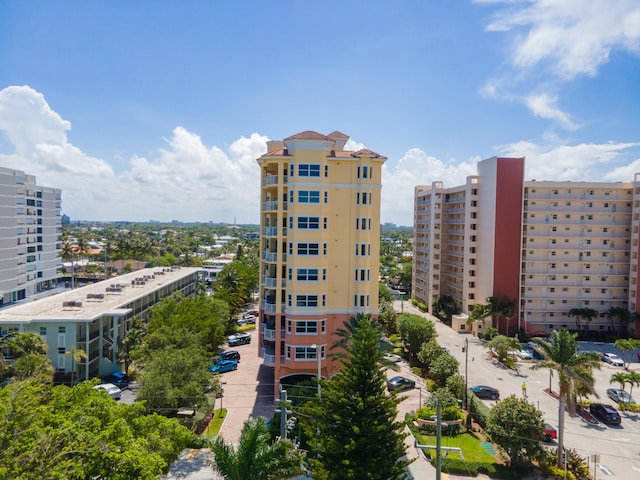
0, 0, 640, 225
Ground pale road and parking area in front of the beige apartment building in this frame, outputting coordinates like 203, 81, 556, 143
404, 302, 640, 480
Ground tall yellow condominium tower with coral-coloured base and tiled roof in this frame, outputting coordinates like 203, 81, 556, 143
257, 131, 386, 391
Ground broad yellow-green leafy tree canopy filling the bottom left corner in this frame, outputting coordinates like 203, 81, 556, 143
0, 380, 192, 480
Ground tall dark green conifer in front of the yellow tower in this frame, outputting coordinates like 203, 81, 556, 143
300, 314, 408, 480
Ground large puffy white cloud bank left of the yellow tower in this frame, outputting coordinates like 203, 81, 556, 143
0, 86, 267, 223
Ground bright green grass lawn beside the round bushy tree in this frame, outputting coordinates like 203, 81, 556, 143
416, 433, 526, 480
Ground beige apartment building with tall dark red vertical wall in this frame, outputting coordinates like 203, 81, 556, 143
412, 157, 640, 339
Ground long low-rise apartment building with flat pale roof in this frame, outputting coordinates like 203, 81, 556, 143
0, 267, 202, 380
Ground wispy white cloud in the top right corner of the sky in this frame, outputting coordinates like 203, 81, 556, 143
475, 0, 640, 130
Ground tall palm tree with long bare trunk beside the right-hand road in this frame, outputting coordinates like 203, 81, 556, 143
532, 330, 601, 467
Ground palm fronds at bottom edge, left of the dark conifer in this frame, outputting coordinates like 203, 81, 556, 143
210, 418, 303, 480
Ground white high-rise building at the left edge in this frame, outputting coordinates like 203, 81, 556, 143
0, 167, 62, 306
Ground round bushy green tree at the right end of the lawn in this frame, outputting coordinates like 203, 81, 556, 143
487, 395, 544, 466
